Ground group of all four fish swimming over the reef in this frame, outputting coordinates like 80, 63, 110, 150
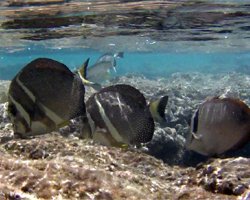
8, 52, 250, 156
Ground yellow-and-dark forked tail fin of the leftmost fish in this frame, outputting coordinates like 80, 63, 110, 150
77, 58, 102, 90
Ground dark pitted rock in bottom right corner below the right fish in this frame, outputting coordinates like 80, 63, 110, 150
197, 157, 250, 195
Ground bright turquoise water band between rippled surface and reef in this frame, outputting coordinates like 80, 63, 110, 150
0, 48, 250, 80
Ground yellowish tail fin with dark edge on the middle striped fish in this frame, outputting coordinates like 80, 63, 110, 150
149, 96, 168, 123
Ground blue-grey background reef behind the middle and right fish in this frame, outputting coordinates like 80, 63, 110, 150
109, 72, 250, 165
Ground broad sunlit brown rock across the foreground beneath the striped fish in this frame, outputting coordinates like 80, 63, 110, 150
0, 132, 244, 200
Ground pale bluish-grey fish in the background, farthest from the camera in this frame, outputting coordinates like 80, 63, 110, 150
81, 52, 123, 84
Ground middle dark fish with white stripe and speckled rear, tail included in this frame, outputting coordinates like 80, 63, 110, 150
82, 84, 168, 146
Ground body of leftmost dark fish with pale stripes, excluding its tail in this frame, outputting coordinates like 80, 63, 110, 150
8, 58, 86, 138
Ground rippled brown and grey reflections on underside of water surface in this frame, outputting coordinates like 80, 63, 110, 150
0, 0, 250, 51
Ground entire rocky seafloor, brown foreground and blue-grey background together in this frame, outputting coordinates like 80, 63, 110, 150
0, 72, 250, 200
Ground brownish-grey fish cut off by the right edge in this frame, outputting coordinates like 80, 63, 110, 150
187, 97, 250, 156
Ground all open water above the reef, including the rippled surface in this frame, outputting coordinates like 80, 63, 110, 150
0, 0, 250, 80
